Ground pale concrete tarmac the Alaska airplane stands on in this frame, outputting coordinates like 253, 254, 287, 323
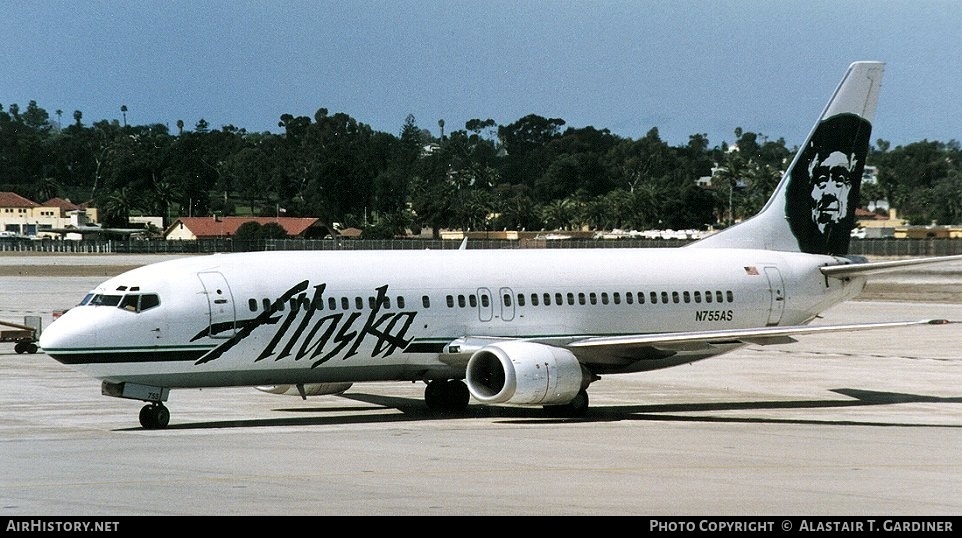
0, 255, 962, 517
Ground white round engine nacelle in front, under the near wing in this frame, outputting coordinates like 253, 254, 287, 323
465, 341, 585, 405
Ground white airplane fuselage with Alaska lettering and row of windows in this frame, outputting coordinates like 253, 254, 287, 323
41, 248, 864, 387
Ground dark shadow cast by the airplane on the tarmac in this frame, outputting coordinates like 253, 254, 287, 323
122, 388, 962, 431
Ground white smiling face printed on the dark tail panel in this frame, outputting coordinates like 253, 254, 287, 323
808, 151, 856, 233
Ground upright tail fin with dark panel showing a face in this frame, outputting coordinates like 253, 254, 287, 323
691, 62, 885, 256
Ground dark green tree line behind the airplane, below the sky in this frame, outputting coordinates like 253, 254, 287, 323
0, 101, 962, 238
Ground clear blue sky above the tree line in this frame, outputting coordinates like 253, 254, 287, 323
7, 0, 962, 147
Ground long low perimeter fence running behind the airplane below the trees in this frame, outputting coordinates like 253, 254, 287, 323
0, 238, 962, 258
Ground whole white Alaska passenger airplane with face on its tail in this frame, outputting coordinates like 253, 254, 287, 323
40, 62, 962, 429
